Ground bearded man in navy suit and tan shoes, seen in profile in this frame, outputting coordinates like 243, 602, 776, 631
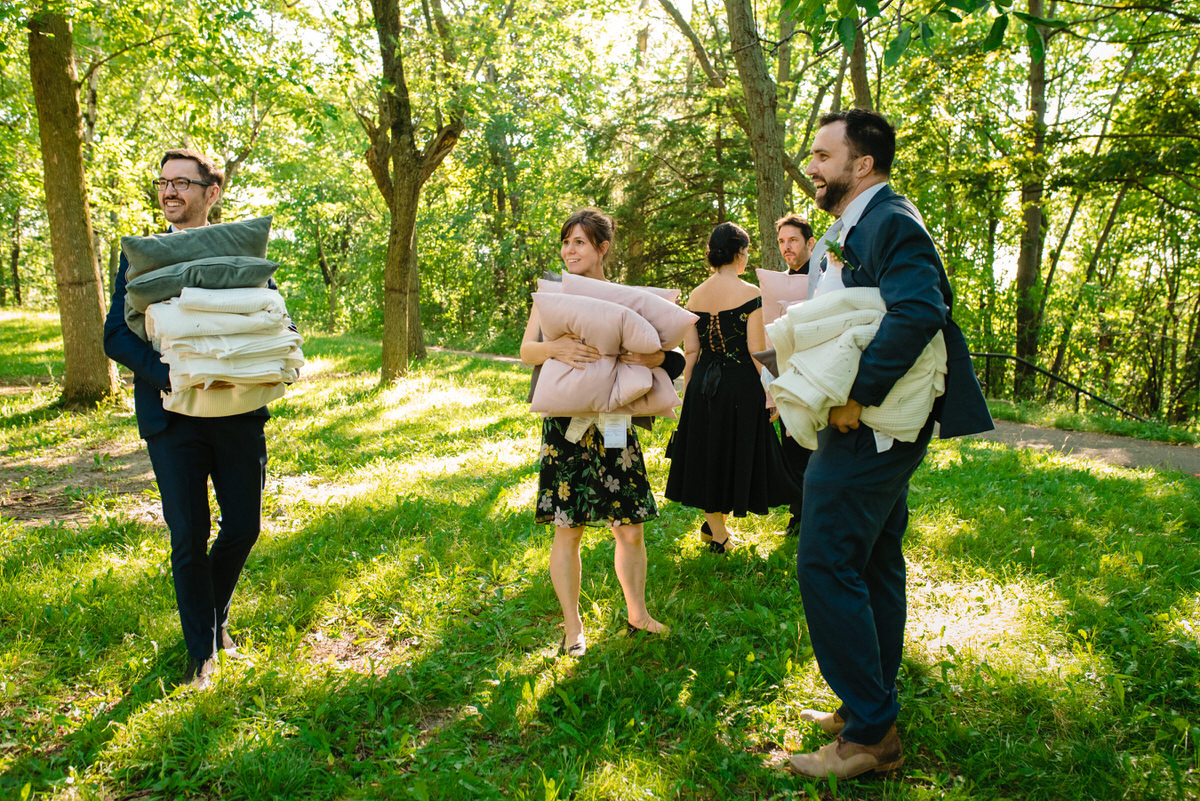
788, 109, 992, 778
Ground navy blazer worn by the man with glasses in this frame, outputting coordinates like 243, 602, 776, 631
104, 253, 275, 439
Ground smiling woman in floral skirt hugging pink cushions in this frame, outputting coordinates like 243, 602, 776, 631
521, 209, 683, 656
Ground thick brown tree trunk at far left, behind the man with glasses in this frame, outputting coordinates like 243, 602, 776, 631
29, 11, 118, 408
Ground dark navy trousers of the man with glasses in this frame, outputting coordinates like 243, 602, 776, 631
146, 415, 266, 660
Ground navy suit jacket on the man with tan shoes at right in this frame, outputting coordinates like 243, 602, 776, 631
842, 186, 995, 439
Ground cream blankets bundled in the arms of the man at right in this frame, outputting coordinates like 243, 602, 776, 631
767, 287, 946, 450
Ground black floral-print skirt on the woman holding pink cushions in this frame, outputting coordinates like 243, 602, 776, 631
535, 417, 659, 529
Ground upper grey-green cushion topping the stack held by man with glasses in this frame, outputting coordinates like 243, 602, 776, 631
121, 217, 271, 281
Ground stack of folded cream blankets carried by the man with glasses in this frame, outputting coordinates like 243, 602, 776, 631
146, 287, 304, 417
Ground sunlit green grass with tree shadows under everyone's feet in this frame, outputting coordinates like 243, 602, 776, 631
0, 309, 1200, 801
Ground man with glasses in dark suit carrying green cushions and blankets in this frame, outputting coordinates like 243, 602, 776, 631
104, 150, 266, 689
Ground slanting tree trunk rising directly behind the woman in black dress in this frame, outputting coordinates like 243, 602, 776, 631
725, 0, 791, 271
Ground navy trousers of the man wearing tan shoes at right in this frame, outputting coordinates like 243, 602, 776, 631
796, 417, 934, 745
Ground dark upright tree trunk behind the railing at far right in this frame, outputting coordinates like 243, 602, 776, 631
1013, 0, 1046, 401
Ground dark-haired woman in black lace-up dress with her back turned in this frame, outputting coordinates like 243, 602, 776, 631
666, 223, 799, 553
